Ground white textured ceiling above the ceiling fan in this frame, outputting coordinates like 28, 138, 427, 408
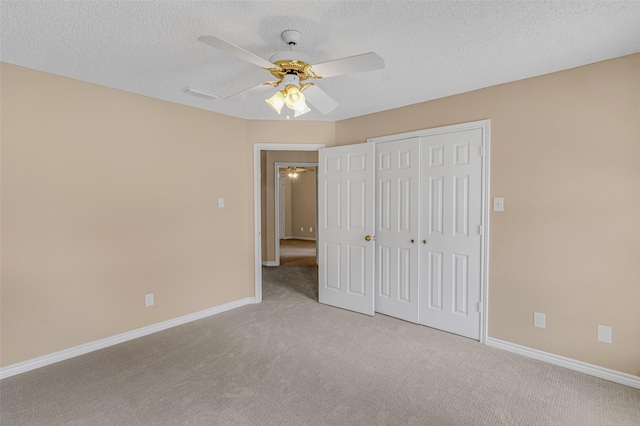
0, 0, 640, 121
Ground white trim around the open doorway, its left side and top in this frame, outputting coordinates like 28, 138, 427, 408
253, 143, 326, 303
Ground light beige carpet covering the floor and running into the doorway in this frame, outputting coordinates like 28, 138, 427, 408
0, 251, 640, 426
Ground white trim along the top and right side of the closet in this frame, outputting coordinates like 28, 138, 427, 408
367, 119, 491, 343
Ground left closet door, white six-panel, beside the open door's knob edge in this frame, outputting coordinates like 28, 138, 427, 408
375, 137, 420, 323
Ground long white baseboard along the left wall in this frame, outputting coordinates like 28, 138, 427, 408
0, 297, 255, 379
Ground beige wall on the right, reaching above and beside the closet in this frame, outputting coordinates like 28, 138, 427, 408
336, 54, 640, 375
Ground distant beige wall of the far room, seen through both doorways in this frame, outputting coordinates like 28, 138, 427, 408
290, 171, 317, 243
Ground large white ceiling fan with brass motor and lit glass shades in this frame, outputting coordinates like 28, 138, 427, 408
198, 30, 384, 117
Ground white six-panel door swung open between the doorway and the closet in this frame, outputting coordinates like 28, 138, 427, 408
317, 143, 375, 315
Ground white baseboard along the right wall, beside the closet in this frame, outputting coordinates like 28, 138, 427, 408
486, 337, 640, 389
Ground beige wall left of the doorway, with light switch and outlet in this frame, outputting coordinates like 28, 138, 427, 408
0, 63, 253, 366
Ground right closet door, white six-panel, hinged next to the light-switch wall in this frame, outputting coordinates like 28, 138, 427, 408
420, 129, 483, 339
